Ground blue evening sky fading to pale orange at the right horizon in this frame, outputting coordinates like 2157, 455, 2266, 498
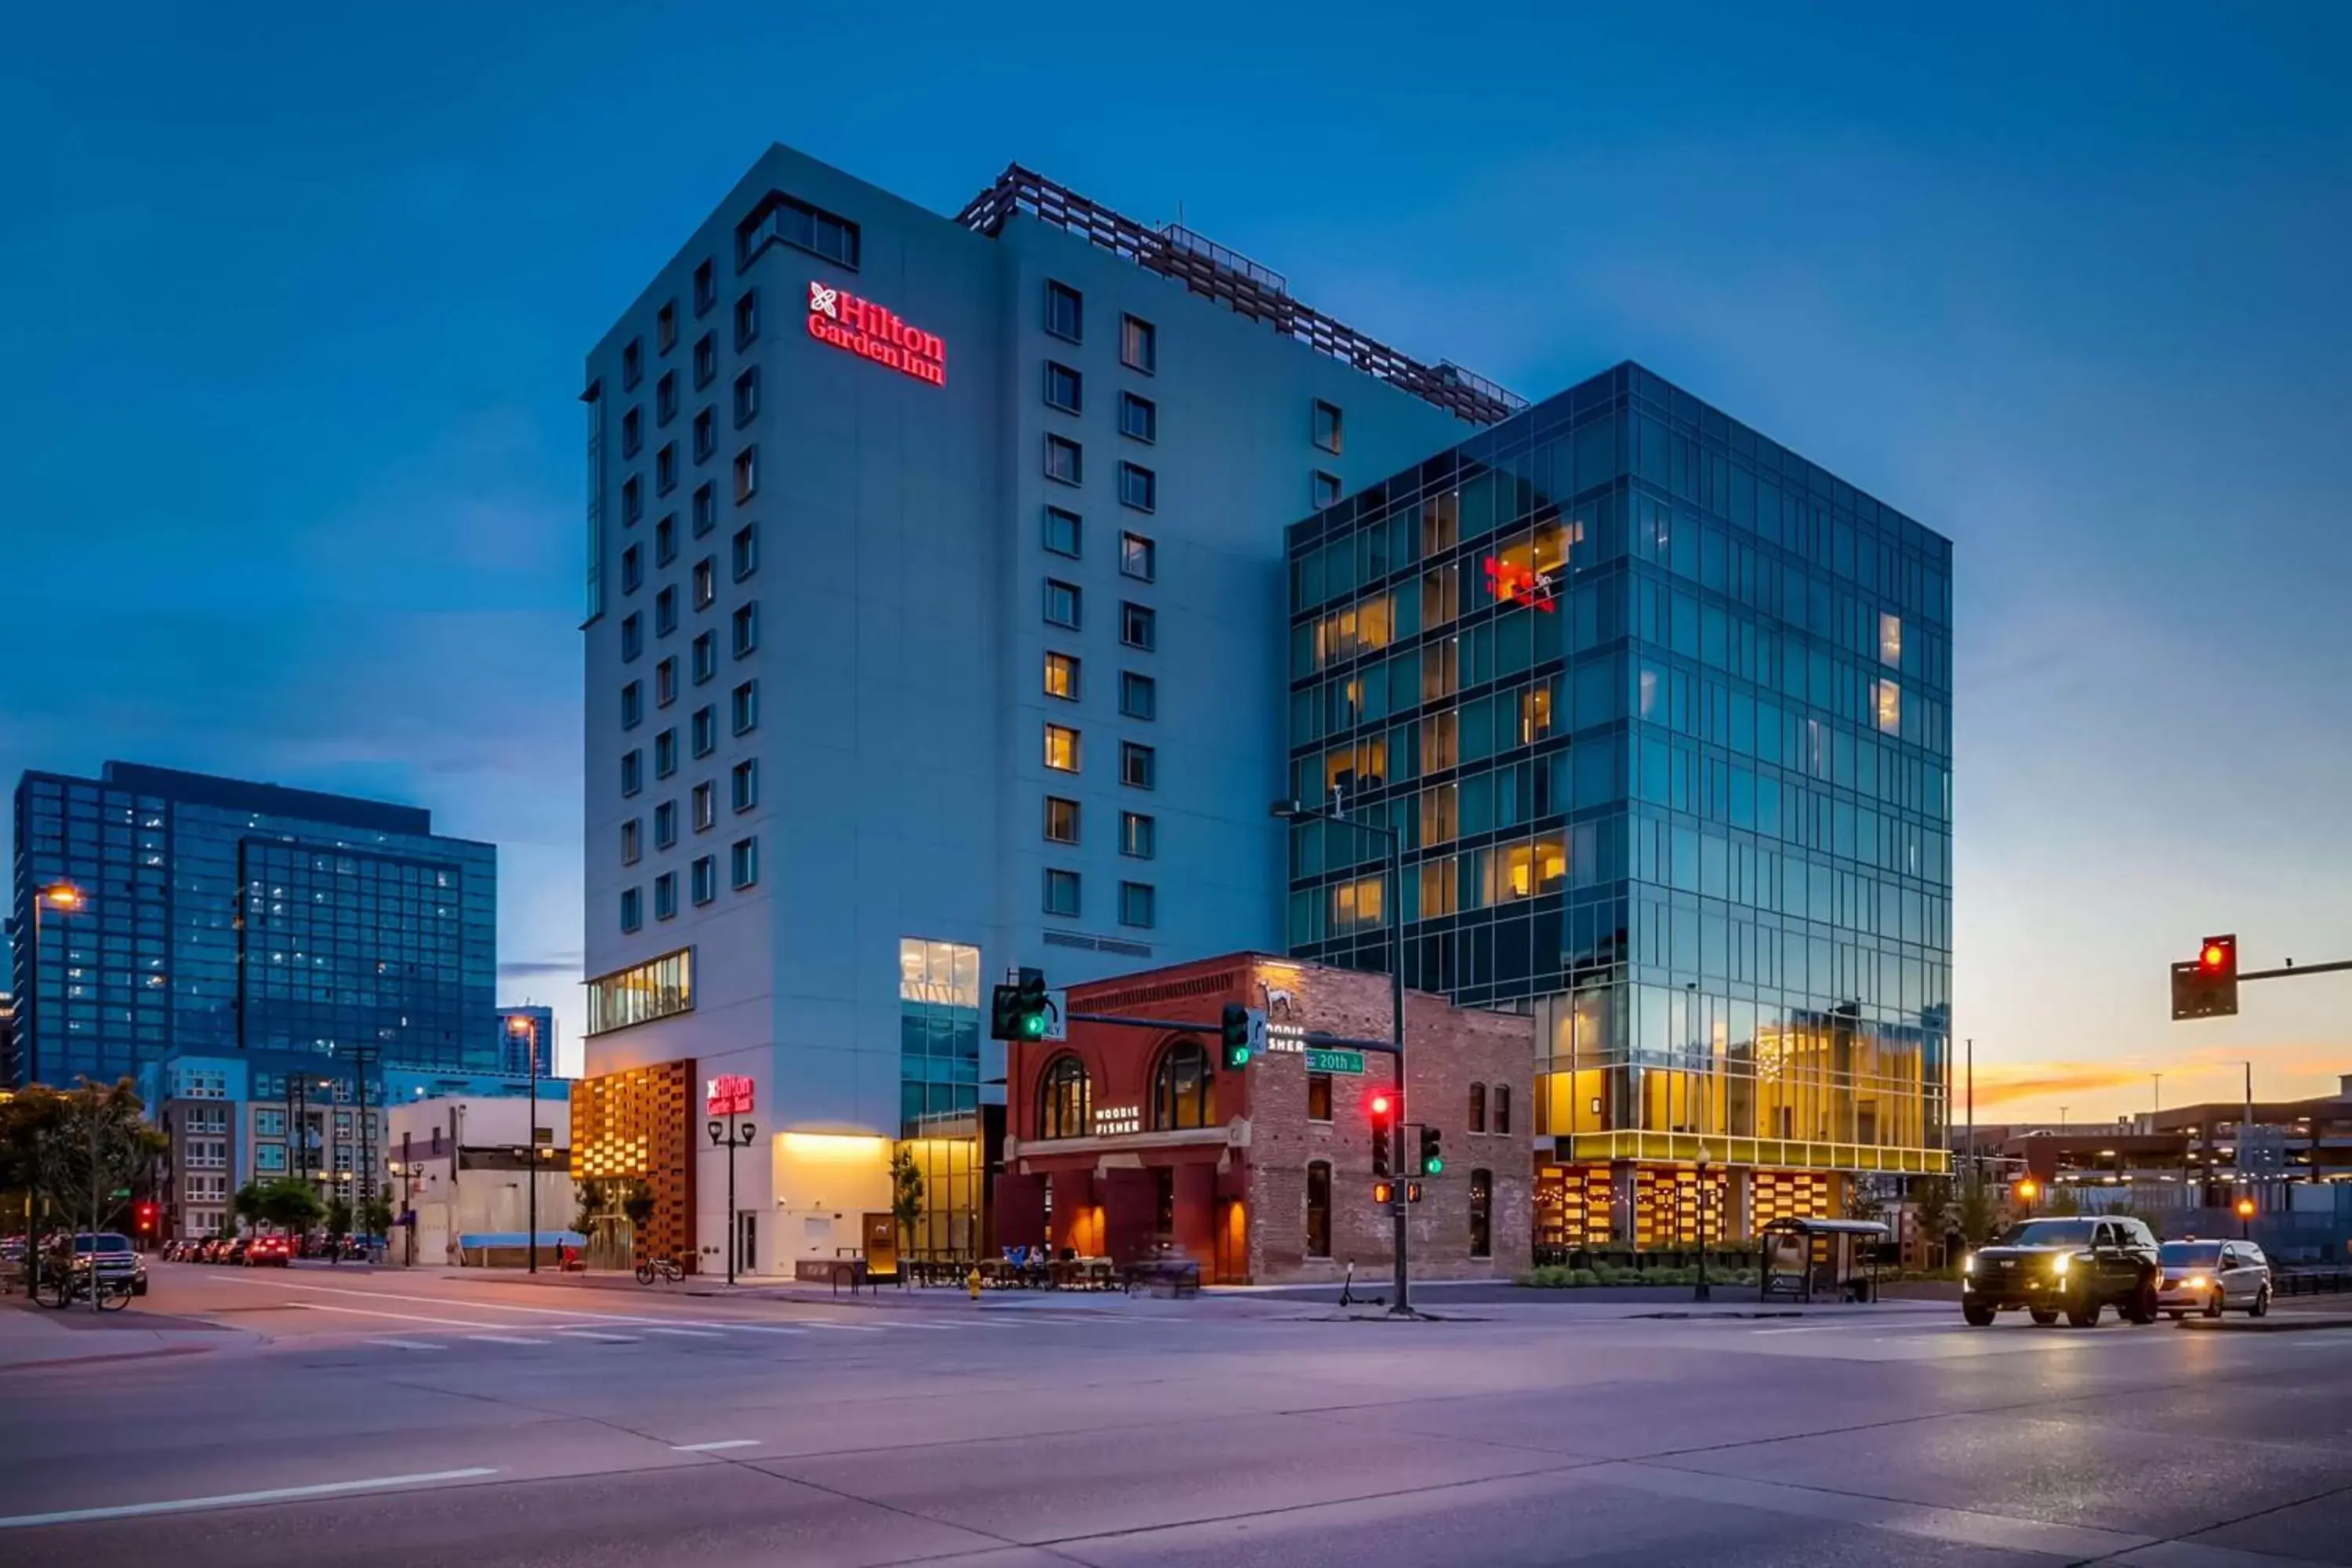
0, 2, 2352, 1119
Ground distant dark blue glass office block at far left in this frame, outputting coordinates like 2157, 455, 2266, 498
7, 762, 501, 1083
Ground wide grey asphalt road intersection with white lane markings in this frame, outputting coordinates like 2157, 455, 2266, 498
0, 1265, 2352, 1568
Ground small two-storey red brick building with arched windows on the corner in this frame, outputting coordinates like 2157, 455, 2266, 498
995, 952, 1536, 1283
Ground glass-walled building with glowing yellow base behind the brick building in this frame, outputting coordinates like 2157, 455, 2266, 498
1289, 365, 1952, 1248
